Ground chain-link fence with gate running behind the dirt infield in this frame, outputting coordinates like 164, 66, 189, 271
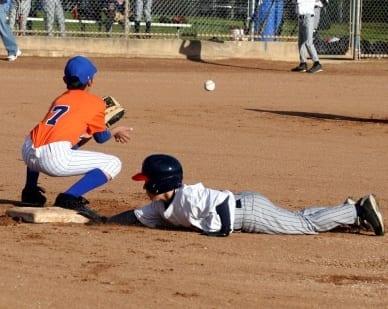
9, 0, 388, 58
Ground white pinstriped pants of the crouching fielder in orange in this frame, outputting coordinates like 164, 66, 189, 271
22, 136, 121, 179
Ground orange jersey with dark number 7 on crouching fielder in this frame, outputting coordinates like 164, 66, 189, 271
30, 89, 106, 148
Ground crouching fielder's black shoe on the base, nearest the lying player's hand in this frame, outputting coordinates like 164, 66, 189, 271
54, 193, 101, 223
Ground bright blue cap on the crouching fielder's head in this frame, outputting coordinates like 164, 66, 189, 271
65, 56, 97, 85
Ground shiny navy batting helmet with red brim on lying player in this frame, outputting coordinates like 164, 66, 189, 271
132, 154, 183, 194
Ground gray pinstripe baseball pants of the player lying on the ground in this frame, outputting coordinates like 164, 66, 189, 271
234, 191, 357, 234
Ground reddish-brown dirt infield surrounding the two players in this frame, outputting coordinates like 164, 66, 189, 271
0, 57, 388, 308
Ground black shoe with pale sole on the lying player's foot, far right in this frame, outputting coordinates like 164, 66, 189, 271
356, 194, 384, 236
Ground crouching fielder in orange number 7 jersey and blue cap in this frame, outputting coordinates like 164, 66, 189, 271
21, 56, 132, 219
